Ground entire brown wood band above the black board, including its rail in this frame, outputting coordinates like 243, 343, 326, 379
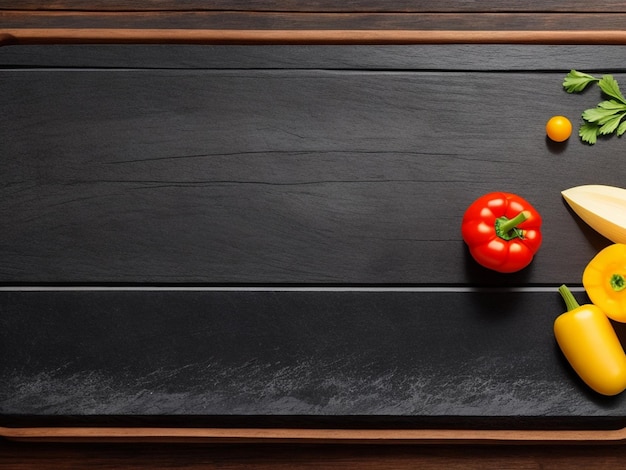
0, 1, 626, 45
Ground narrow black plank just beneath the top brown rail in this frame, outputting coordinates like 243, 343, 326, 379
0, 44, 626, 73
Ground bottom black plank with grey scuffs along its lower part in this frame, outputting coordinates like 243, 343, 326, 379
0, 290, 624, 428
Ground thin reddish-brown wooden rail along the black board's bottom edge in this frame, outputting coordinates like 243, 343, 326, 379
0, 427, 626, 444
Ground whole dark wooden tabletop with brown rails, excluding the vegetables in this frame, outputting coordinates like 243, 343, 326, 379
0, 1, 626, 469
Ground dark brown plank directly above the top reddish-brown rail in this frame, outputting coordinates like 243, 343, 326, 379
0, 10, 626, 34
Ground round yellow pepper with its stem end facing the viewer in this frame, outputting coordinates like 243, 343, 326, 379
583, 243, 626, 322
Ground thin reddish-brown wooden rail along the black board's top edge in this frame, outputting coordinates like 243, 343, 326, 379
0, 28, 626, 46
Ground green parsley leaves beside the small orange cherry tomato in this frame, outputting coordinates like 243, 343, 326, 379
563, 70, 626, 145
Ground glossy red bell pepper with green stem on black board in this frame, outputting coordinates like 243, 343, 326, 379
461, 192, 541, 273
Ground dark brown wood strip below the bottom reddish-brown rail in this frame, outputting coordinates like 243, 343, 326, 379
0, 442, 626, 470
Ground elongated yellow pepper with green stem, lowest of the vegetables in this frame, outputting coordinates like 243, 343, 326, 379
554, 285, 626, 395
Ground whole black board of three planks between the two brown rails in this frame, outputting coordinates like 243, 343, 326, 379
0, 46, 626, 428
